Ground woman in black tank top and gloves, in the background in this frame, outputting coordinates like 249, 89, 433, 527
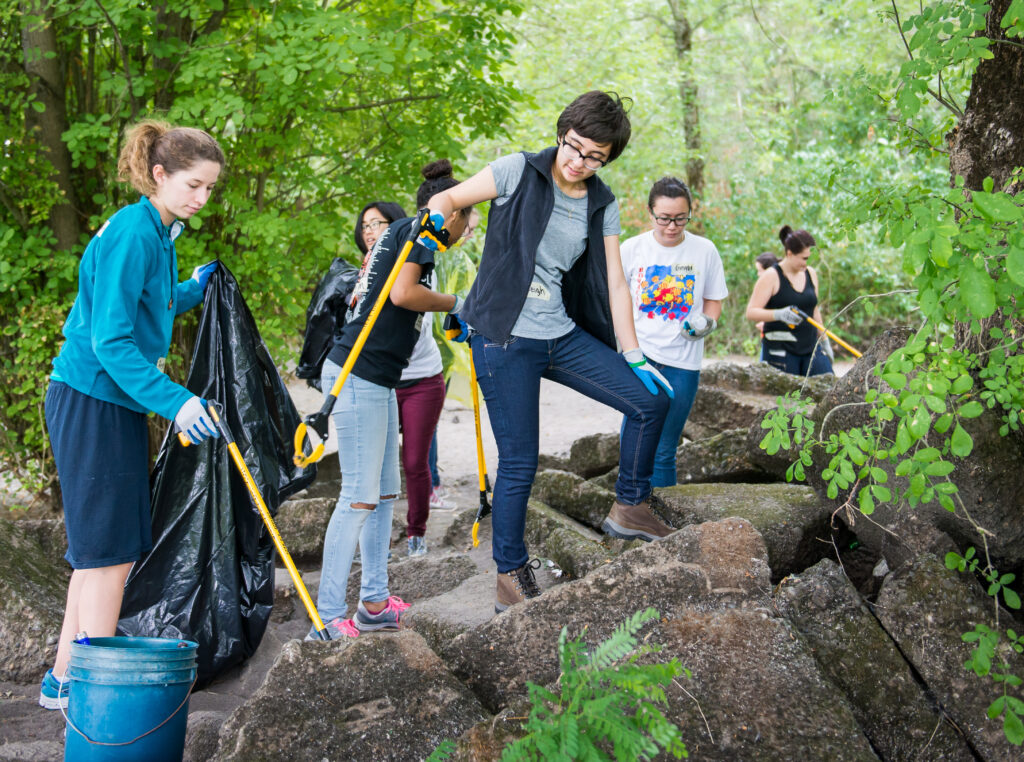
746, 225, 833, 376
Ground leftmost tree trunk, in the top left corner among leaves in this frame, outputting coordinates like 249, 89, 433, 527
22, 0, 81, 251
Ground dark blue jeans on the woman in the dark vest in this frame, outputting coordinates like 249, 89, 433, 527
470, 328, 669, 573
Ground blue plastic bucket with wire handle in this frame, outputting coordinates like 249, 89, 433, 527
65, 637, 199, 762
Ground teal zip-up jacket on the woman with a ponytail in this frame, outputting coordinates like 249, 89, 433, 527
52, 197, 203, 419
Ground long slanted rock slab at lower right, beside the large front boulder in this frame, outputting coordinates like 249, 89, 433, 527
775, 558, 974, 762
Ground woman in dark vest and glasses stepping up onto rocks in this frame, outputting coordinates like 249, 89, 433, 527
419, 90, 673, 611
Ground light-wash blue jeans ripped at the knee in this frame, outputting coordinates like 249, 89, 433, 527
316, 359, 401, 623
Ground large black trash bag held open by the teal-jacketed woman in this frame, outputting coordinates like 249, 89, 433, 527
118, 263, 316, 686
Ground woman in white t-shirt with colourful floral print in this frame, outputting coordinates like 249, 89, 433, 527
622, 177, 729, 486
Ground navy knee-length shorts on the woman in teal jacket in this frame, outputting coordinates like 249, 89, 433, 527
46, 380, 153, 568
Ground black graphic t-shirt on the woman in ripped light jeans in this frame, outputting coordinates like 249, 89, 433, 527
328, 217, 434, 389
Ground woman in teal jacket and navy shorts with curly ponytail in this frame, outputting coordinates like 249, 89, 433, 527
39, 122, 224, 709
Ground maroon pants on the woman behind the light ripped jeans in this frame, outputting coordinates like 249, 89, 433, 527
395, 373, 444, 537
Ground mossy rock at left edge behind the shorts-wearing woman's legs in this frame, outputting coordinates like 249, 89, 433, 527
0, 519, 68, 683
